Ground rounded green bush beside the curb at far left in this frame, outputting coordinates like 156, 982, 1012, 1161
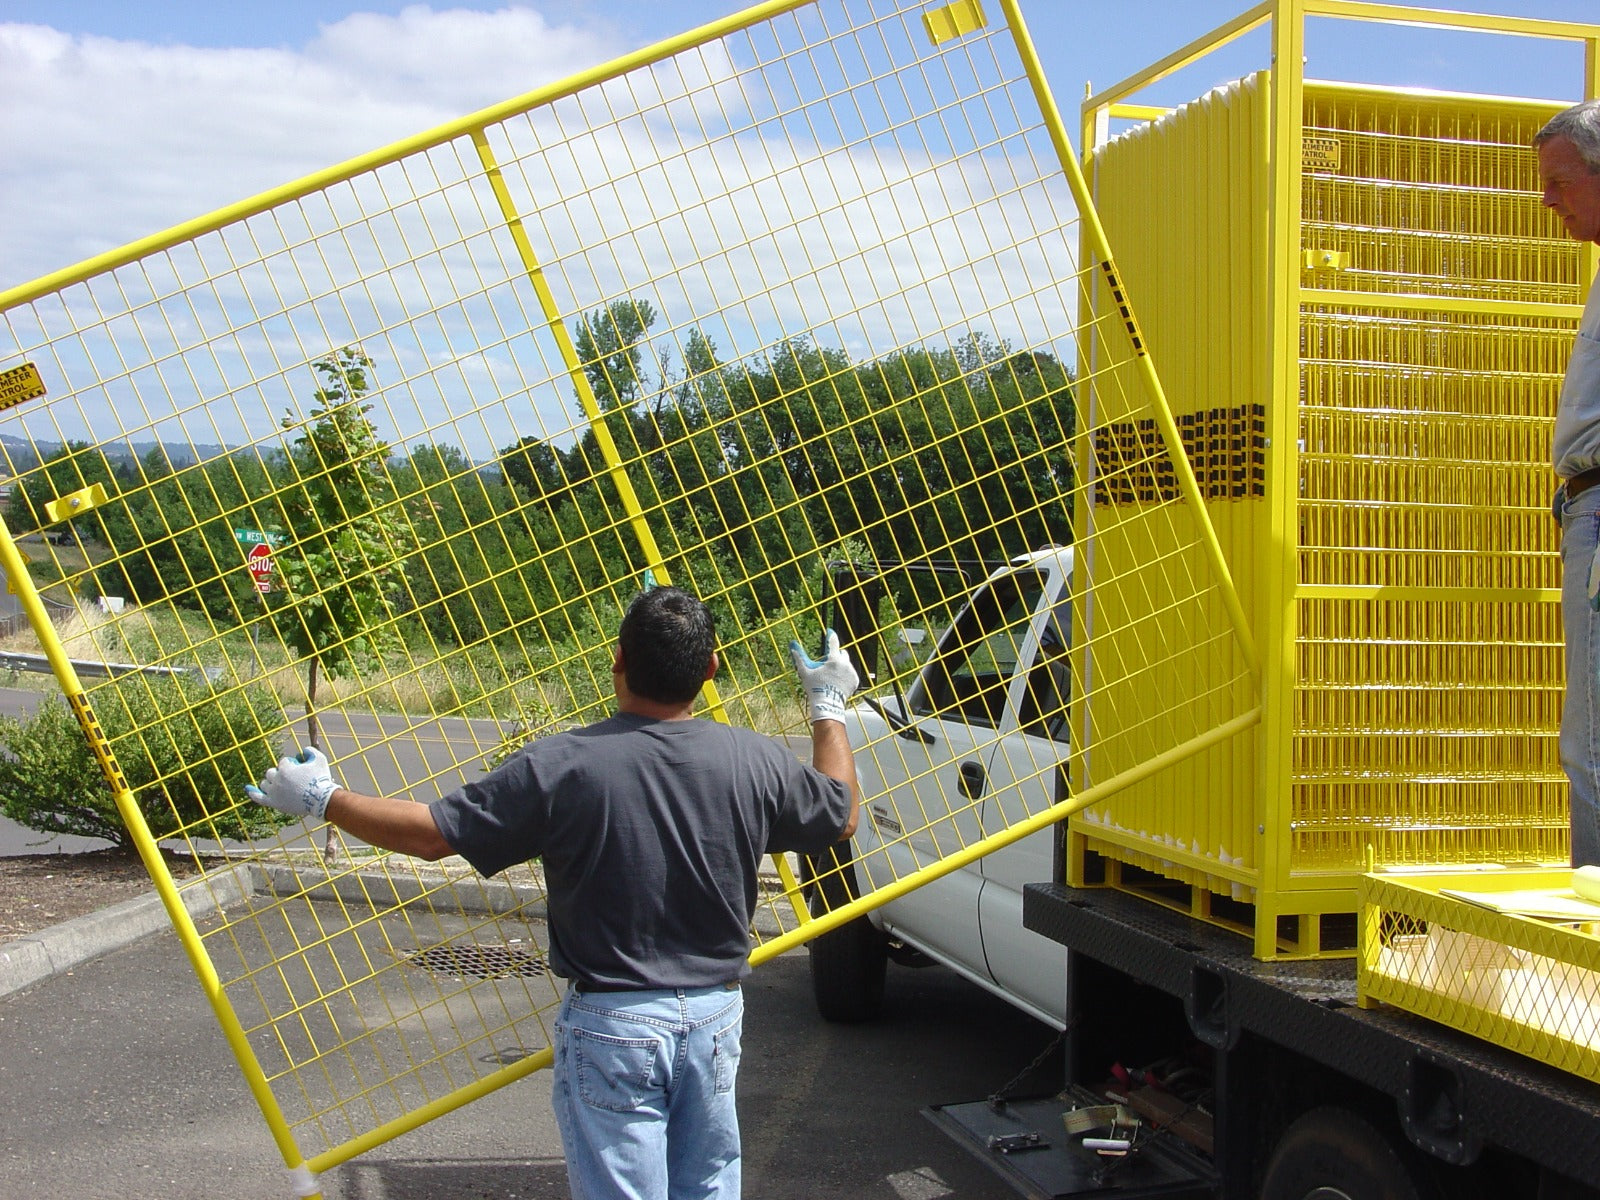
0, 675, 288, 850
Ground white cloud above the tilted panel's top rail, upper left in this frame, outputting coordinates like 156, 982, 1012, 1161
0, 5, 627, 288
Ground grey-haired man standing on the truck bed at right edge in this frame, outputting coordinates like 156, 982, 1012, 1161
1533, 101, 1600, 867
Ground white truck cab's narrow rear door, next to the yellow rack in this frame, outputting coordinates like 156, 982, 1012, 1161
978, 579, 1072, 1022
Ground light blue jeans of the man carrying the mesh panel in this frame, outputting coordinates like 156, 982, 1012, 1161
552, 986, 744, 1200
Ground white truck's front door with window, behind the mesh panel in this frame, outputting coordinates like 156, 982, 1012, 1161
870, 570, 1045, 982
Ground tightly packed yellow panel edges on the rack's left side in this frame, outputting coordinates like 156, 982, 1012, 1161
1074, 78, 1270, 923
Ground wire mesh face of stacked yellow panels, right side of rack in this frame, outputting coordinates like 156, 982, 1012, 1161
1291, 86, 1584, 872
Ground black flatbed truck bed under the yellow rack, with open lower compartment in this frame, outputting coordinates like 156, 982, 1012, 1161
930, 883, 1600, 1200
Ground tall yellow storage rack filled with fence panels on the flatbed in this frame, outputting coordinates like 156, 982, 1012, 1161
1069, 2, 1600, 957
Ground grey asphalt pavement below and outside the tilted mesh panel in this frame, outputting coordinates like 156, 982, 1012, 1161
0, 908, 1062, 1200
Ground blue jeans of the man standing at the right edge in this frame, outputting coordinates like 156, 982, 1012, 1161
1560, 486, 1600, 867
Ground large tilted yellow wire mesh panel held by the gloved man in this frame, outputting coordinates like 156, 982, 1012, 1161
0, 3, 1254, 1170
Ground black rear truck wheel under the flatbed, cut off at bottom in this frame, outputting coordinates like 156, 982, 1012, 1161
1261, 1107, 1430, 1200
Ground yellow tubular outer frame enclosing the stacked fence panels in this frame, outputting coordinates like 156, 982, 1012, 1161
1074, 0, 1600, 958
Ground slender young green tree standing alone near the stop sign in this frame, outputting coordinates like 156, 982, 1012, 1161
269, 347, 416, 747
